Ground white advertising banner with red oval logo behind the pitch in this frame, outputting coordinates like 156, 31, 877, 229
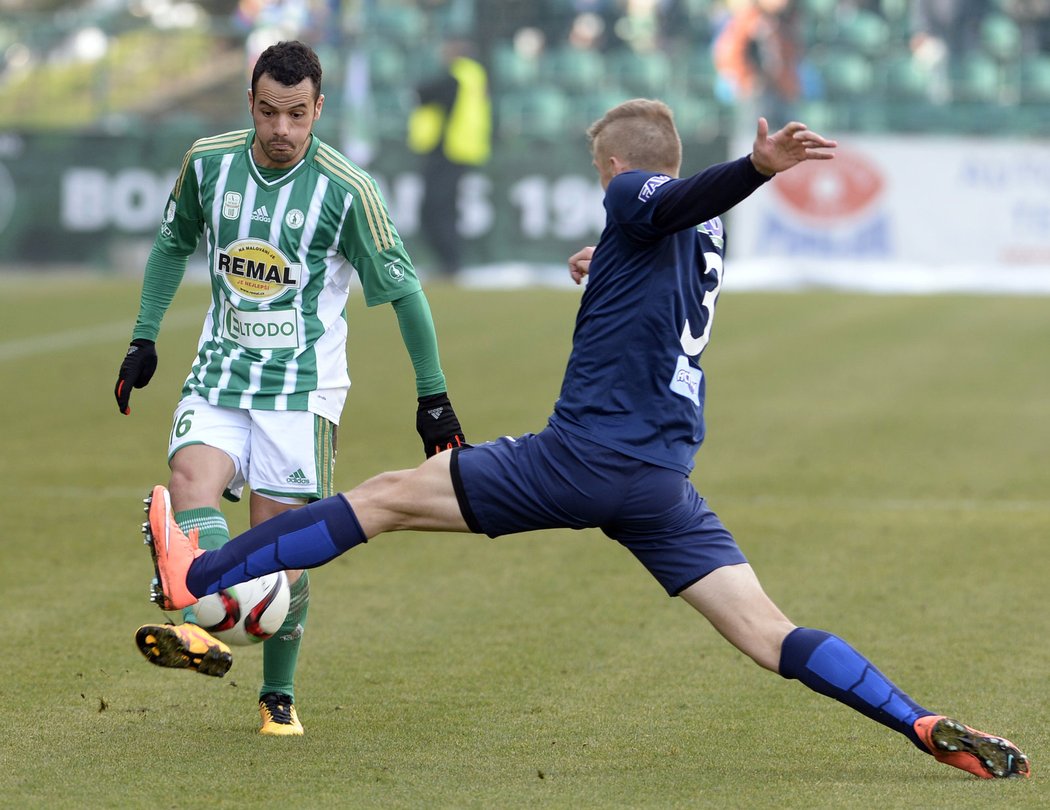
727, 136, 1050, 293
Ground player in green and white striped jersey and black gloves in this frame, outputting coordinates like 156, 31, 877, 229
114, 42, 464, 734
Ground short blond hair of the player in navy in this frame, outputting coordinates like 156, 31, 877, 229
587, 99, 681, 174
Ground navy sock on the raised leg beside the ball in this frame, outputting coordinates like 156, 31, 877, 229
186, 495, 368, 597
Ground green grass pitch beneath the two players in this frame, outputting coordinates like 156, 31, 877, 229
0, 277, 1050, 808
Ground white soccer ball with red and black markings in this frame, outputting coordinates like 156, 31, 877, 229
193, 570, 290, 646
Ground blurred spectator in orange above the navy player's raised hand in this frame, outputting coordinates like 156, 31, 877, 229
713, 0, 802, 129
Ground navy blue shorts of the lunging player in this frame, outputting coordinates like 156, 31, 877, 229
452, 427, 748, 596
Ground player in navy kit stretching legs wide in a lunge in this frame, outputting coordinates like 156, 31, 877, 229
135, 99, 1030, 778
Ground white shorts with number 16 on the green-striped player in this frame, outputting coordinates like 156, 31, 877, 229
168, 394, 336, 501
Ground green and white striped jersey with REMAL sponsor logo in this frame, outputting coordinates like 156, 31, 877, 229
158, 129, 420, 423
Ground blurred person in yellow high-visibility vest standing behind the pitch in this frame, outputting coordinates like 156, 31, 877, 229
408, 40, 492, 277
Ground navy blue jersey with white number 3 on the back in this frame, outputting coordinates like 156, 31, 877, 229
550, 158, 768, 475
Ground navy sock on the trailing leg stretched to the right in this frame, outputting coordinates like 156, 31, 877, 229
780, 627, 933, 753
